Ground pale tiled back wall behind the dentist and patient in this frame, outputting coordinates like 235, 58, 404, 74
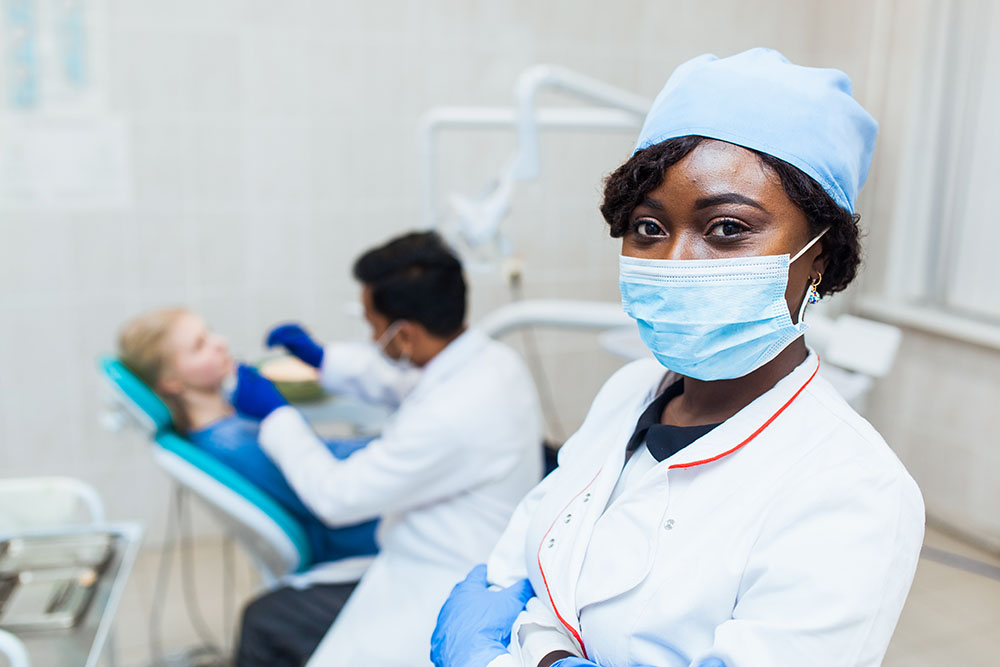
0, 0, 928, 540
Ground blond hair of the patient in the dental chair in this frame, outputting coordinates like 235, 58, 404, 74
118, 307, 191, 432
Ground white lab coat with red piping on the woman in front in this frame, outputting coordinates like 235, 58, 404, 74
488, 354, 924, 667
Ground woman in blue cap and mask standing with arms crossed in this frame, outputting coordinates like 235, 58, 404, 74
431, 49, 923, 667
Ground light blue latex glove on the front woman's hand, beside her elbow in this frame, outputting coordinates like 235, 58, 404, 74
431, 565, 535, 667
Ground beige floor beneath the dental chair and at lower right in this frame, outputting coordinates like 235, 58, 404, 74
105, 529, 1000, 667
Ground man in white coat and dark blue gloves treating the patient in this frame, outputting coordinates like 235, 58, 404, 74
234, 232, 542, 667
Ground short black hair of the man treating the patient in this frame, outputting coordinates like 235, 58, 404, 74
354, 232, 466, 338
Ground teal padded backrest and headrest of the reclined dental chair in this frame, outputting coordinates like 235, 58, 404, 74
99, 357, 316, 588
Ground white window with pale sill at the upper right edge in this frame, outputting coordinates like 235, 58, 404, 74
869, 0, 1000, 336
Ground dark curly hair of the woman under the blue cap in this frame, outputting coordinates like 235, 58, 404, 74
601, 136, 861, 296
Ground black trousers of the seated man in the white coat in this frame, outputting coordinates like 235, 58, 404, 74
236, 582, 358, 667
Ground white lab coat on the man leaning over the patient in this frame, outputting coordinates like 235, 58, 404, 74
260, 329, 542, 667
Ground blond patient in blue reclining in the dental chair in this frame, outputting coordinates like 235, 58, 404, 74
118, 308, 377, 562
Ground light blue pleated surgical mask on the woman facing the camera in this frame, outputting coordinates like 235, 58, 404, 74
619, 230, 826, 380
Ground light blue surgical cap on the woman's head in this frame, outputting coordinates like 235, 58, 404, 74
635, 48, 878, 213
